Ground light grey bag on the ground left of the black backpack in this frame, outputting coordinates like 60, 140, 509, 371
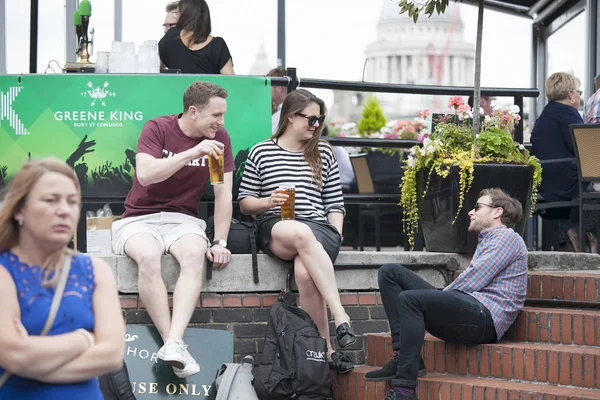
215, 356, 258, 400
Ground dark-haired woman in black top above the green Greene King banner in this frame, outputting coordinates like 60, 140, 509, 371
158, 0, 234, 75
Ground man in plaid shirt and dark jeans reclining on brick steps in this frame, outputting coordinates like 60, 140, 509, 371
365, 189, 527, 400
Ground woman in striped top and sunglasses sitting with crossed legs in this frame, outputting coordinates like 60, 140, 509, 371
238, 89, 356, 372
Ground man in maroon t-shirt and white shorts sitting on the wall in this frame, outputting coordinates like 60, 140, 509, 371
112, 82, 235, 378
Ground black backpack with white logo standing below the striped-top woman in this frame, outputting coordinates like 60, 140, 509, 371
252, 299, 333, 400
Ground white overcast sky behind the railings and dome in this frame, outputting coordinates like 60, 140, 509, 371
6, 0, 595, 102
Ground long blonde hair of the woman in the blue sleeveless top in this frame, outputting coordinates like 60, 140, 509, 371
0, 157, 81, 285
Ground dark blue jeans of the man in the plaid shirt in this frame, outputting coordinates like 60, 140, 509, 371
379, 264, 496, 388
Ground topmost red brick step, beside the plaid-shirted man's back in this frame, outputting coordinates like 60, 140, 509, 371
527, 271, 600, 303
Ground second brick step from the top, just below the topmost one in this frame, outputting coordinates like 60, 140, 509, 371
502, 307, 600, 346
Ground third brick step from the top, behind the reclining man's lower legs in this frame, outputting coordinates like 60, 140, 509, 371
367, 334, 600, 388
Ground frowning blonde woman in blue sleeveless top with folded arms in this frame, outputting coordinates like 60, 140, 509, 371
0, 159, 125, 400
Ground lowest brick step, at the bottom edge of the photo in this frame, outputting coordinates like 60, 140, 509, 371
333, 366, 600, 400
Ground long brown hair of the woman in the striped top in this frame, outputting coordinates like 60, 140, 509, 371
273, 89, 327, 188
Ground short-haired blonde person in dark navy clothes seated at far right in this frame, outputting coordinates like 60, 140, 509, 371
531, 72, 598, 253
